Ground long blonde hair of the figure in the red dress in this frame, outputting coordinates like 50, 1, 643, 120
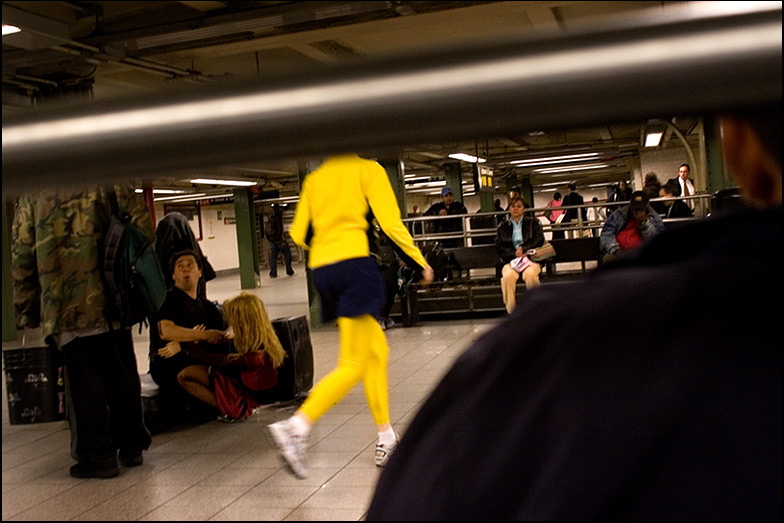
223, 292, 286, 368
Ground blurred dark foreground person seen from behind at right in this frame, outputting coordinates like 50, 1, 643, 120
367, 103, 782, 521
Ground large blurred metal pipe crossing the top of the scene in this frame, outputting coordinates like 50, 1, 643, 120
3, 2, 782, 192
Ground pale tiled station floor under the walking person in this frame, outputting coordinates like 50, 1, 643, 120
2, 266, 500, 521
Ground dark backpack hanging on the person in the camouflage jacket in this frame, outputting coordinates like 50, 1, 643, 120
101, 189, 166, 331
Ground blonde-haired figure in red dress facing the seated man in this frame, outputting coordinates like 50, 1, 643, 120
172, 292, 286, 420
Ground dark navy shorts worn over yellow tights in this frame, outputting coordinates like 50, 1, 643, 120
313, 257, 384, 323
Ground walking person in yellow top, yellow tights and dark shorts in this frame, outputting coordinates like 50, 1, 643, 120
268, 155, 433, 478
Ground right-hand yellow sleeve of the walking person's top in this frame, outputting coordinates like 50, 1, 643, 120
367, 164, 427, 269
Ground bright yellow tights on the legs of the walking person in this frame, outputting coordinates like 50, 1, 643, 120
298, 314, 389, 425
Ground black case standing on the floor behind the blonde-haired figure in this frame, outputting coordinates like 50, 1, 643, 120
271, 316, 313, 401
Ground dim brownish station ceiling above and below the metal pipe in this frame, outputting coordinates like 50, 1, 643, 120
3, 1, 698, 201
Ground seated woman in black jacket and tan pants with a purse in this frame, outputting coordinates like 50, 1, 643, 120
495, 198, 544, 314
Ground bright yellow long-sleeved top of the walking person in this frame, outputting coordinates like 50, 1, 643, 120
289, 155, 427, 269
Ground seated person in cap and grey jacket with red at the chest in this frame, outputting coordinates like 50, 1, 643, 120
599, 191, 664, 263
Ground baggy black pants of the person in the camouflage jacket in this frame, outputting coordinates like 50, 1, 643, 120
63, 329, 152, 465
